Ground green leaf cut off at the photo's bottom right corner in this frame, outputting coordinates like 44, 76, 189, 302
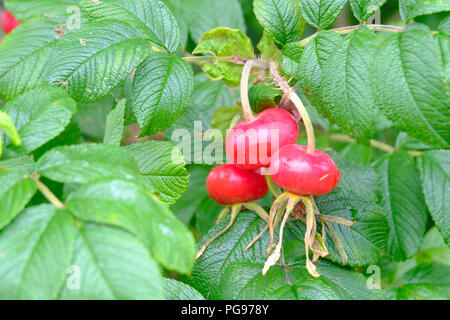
397, 263, 450, 300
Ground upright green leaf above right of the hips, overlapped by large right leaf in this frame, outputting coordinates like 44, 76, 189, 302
322, 28, 376, 145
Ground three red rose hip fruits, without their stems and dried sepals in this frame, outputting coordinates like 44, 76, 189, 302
206, 108, 340, 205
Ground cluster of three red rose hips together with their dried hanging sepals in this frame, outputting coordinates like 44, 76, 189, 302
197, 95, 346, 277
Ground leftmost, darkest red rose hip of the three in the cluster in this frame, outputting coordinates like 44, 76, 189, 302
206, 164, 269, 205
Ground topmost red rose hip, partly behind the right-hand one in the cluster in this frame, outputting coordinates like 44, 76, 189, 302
225, 108, 298, 170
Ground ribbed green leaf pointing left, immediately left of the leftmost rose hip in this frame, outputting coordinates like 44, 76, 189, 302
127, 141, 189, 204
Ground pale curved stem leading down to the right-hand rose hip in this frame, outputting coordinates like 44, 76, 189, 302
270, 62, 316, 153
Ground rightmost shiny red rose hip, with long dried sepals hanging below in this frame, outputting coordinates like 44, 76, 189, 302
271, 144, 341, 196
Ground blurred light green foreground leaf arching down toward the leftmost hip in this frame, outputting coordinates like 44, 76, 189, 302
67, 179, 195, 274
